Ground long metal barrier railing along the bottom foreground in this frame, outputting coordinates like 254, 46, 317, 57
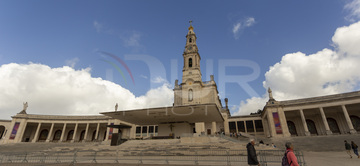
0, 149, 305, 166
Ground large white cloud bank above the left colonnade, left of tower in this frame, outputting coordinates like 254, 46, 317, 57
0, 63, 173, 119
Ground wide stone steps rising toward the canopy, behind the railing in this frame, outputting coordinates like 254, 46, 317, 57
0, 137, 288, 165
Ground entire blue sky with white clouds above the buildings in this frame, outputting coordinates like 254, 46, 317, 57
0, 0, 360, 119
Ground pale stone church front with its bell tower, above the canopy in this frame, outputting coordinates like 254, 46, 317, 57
174, 21, 222, 109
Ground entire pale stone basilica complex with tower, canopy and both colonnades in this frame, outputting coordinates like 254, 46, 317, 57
0, 25, 360, 144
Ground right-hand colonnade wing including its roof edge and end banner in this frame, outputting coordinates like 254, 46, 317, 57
261, 91, 360, 137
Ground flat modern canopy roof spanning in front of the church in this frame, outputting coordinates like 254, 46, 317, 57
101, 104, 224, 125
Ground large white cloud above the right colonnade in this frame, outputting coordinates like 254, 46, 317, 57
235, 22, 360, 115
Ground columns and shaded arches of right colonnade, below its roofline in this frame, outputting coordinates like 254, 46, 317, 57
263, 103, 360, 137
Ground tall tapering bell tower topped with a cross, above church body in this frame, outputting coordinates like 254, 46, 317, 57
182, 21, 201, 82
